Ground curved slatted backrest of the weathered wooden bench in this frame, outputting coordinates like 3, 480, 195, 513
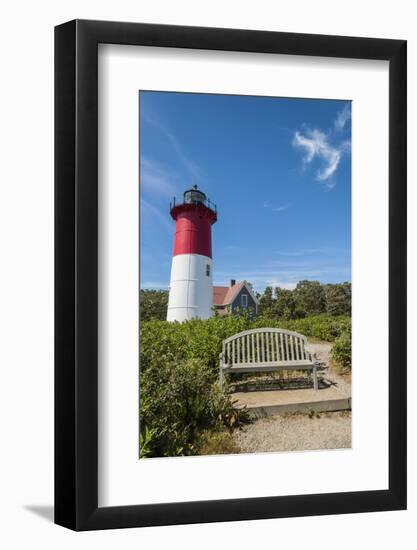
222, 328, 311, 365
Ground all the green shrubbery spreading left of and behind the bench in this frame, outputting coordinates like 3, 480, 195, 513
140, 315, 351, 457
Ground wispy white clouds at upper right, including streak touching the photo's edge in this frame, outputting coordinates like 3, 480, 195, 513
292, 104, 350, 189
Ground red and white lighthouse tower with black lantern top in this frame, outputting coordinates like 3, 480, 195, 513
167, 185, 217, 322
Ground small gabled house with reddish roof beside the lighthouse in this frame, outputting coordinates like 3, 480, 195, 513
213, 279, 259, 315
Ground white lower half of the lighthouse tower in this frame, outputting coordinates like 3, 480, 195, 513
167, 254, 213, 322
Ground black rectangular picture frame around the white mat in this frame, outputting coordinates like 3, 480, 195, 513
55, 20, 407, 531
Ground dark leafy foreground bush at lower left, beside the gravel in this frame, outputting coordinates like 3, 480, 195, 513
140, 358, 249, 457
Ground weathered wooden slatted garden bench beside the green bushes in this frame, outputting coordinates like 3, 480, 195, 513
220, 328, 323, 391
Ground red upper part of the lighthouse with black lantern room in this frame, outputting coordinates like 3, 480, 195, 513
170, 185, 217, 258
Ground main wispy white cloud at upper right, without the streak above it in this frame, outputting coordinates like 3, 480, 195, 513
293, 130, 343, 189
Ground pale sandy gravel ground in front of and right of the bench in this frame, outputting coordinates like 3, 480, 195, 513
234, 342, 351, 453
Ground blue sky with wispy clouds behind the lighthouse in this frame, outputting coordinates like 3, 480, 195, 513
139, 92, 351, 290
